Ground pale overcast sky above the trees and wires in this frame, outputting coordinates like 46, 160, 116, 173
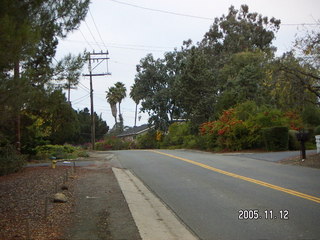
56, 0, 320, 127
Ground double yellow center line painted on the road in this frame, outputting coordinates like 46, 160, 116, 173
149, 150, 320, 203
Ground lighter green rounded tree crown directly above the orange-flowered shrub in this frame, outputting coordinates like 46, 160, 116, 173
216, 50, 270, 113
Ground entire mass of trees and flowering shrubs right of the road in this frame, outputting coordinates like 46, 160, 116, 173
130, 5, 320, 154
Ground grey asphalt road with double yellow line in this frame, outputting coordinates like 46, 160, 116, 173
113, 150, 320, 240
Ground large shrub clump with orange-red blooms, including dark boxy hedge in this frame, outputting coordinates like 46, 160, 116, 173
200, 101, 303, 151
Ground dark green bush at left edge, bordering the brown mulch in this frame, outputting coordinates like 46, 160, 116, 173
0, 145, 26, 176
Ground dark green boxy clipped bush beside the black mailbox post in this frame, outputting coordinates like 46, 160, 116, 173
262, 127, 289, 151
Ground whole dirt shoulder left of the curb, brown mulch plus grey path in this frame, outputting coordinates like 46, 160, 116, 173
0, 154, 140, 240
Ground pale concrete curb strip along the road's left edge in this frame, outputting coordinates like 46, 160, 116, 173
112, 168, 198, 240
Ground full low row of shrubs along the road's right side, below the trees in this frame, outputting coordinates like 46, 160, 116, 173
137, 101, 318, 151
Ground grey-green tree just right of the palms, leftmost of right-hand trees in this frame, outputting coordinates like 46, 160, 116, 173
134, 51, 182, 131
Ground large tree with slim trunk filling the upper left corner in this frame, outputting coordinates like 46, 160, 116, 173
0, 0, 89, 148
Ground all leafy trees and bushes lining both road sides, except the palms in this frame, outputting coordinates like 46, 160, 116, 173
0, 0, 320, 174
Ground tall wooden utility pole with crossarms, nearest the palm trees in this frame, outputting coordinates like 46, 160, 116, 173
83, 51, 111, 150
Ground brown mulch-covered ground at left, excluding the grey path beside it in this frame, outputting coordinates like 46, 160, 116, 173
0, 167, 74, 240
